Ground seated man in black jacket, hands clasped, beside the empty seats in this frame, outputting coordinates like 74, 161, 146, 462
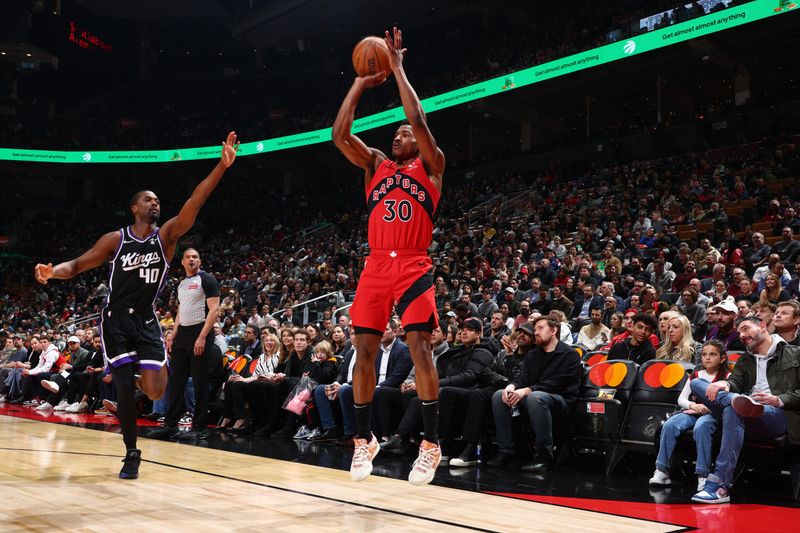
487, 317, 581, 472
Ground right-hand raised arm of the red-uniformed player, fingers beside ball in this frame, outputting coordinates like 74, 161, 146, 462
384, 28, 445, 182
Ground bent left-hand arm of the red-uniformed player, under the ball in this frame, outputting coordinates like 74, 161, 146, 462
332, 72, 386, 175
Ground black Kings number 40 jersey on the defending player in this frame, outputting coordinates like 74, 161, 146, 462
107, 227, 169, 311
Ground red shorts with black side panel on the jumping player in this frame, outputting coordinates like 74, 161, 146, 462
350, 250, 439, 334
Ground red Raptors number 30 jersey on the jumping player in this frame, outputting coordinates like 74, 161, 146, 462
366, 157, 439, 254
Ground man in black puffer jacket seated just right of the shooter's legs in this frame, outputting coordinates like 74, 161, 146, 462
381, 317, 494, 451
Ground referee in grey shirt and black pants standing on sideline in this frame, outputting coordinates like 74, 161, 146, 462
149, 248, 219, 440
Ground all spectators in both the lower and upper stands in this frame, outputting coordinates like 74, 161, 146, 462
0, 2, 800, 502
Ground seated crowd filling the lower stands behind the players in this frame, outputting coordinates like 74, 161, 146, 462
0, 127, 800, 500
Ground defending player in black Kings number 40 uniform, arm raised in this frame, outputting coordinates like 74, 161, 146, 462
34, 132, 239, 479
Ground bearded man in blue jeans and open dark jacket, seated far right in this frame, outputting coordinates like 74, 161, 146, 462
689, 316, 800, 504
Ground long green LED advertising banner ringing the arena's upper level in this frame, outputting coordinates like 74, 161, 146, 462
0, 0, 800, 163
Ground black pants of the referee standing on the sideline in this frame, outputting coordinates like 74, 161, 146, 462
164, 323, 214, 430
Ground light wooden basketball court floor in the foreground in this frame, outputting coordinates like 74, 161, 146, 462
0, 416, 683, 533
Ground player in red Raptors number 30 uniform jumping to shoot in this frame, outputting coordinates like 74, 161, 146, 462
333, 28, 445, 485
